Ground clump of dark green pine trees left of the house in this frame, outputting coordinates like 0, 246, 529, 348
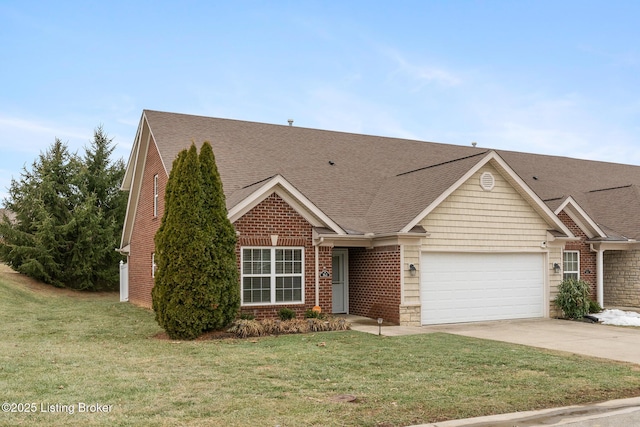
0, 127, 127, 290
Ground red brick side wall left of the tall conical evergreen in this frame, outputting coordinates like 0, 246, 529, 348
128, 142, 168, 308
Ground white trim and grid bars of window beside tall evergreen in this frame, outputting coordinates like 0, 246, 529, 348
240, 246, 305, 307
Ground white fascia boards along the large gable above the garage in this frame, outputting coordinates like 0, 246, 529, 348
401, 151, 574, 237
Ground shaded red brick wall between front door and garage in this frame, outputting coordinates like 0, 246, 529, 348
349, 246, 401, 324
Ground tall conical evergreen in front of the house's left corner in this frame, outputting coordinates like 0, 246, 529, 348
151, 144, 239, 339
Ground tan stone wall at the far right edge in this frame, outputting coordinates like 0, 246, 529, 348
603, 250, 640, 307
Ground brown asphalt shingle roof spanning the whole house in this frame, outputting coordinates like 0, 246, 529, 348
143, 110, 640, 238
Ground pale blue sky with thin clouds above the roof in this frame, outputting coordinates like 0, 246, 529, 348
0, 0, 640, 204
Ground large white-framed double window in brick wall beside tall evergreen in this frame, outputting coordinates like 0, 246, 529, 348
241, 247, 304, 305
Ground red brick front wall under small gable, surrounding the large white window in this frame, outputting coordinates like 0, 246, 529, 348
234, 193, 332, 318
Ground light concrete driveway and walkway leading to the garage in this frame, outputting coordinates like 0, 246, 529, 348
348, 316, 640, 365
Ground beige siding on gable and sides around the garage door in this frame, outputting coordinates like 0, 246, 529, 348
403, 163, 562, 323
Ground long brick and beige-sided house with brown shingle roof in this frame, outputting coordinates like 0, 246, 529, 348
120, 110, 640, 325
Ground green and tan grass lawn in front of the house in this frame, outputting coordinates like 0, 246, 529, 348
0, 274, 640, 426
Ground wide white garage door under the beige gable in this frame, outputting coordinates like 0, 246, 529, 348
420, 253, 544, 325
